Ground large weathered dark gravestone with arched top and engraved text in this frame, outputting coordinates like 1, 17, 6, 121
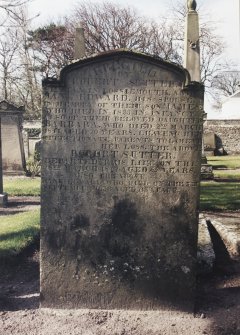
41, 51, 203, 309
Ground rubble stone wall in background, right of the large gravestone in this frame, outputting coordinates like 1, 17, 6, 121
204, 120, 240, 155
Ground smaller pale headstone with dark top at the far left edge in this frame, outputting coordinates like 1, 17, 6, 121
0, 100, 25, 174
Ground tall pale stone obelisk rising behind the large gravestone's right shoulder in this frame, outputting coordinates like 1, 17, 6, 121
184, 0, 201, 82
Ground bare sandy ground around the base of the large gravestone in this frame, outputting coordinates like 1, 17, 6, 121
0, 244, 240, 335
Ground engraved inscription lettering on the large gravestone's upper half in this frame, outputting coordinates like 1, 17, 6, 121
43, 61, 202, 197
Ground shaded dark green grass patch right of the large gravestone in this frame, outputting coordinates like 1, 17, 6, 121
200, 181, 240, 211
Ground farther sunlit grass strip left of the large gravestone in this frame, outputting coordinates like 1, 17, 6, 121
3, 177, 41, 196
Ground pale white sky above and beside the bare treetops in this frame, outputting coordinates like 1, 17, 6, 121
29, 0, 240, 117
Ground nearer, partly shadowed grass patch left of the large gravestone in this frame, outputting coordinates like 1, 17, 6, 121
0, 210, 40, 259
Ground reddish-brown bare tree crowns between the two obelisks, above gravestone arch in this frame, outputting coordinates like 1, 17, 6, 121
66, 2, 189, 63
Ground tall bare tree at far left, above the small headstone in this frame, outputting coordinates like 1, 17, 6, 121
0, 6, 41, 117
